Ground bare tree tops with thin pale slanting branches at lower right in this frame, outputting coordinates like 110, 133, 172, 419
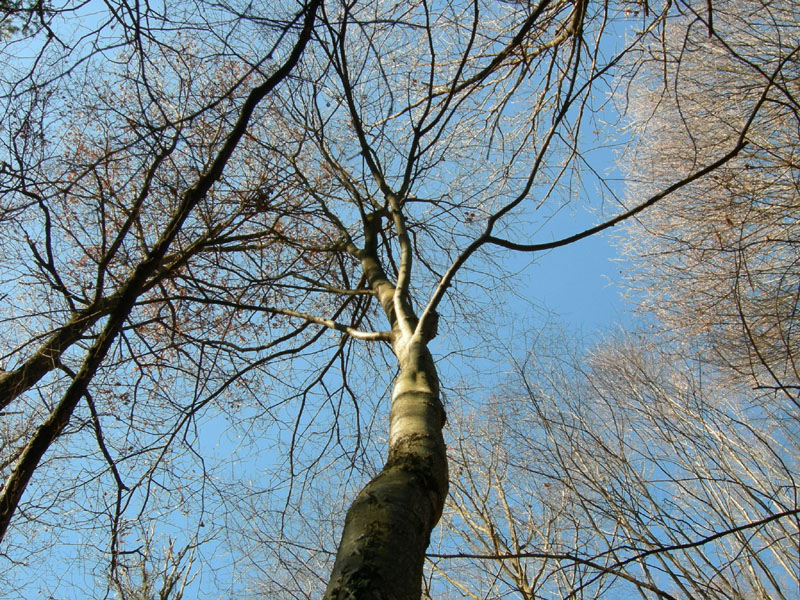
431, 332, 800, 598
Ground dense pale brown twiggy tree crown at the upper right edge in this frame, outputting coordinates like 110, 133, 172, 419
622, 1, 800, 398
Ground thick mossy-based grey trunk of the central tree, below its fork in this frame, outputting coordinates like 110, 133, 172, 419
325, 339, 448, 600
